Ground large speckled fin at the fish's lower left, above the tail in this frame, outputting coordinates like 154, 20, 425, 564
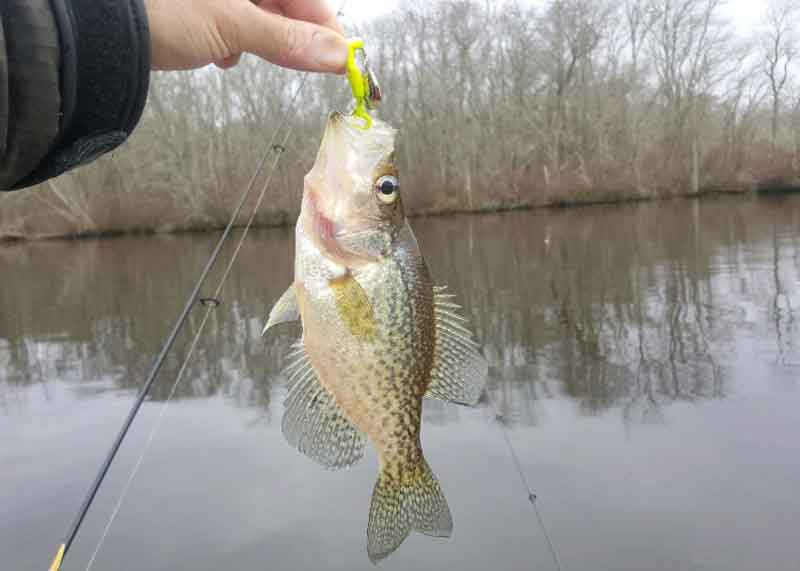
281, 341, 366, 469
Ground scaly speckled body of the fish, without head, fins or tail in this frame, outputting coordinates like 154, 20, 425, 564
302, 223, 434, 478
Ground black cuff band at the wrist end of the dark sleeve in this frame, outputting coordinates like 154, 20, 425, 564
10, 0, 150, 192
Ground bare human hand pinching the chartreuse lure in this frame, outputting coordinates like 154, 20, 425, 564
145, 0, 347, 73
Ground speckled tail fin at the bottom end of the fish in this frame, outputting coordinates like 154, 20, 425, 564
367, 459, 453, 563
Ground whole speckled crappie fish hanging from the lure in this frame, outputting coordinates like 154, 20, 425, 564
264, 113, 487, 563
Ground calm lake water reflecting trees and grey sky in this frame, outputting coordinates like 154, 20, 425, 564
0, 197, 800, 571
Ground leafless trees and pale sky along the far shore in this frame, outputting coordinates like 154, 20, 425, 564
0, 0, 800, 237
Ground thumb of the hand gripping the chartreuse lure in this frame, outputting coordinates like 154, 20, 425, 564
230, 2, 347, 73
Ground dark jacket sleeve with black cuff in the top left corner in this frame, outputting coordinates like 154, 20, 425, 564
0, 0, 150, 190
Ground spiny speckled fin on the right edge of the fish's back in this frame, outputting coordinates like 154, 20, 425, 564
425, 287, 488, 405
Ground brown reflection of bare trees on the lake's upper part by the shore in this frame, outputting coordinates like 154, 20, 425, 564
0, 197, 800, 425
